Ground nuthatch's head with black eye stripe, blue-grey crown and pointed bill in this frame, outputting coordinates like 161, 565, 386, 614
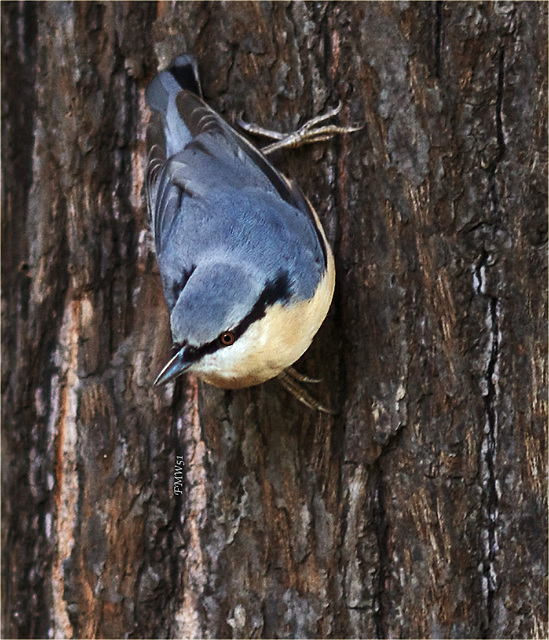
155, 262, 300, 388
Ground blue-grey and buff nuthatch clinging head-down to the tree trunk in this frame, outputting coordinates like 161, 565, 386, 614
146, 55, 355, 408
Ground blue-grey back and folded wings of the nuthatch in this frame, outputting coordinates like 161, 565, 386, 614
147, 91, 326, 308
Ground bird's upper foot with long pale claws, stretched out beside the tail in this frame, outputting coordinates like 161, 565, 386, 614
237, 102, 364, 155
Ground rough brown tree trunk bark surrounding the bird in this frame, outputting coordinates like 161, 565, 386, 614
1, 2, 548, 638
